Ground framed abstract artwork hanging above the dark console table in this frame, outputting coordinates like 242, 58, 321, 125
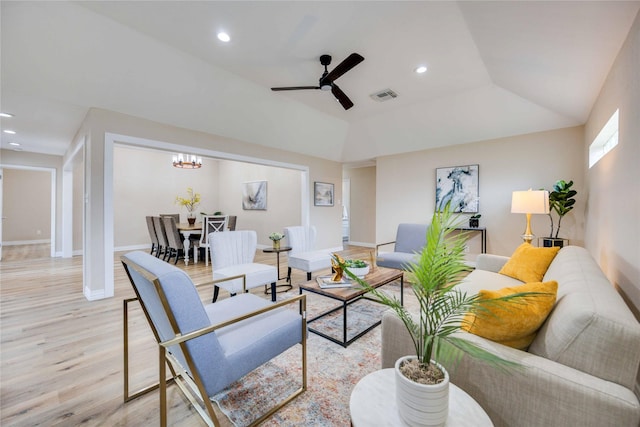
436, 165, 479, 213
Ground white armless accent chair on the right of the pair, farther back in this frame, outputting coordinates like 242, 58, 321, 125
284, 225, 331, 283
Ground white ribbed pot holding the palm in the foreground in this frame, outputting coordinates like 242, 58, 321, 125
395, 356, 449, 427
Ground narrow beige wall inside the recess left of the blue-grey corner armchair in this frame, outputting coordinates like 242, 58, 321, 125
344, 166, 376, 246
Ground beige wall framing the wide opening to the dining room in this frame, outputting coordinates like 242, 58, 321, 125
62, 109, 342, 300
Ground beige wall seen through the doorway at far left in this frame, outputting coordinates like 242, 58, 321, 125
2, 168, 51, 245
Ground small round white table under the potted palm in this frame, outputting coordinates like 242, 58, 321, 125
349, 368, 493, 427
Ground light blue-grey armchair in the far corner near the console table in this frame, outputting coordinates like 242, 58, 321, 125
376, 224, 429, 270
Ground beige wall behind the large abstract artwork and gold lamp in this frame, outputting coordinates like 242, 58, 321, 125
376, 126, 586, 255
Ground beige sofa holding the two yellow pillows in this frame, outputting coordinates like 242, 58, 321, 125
382, 246, 640, 427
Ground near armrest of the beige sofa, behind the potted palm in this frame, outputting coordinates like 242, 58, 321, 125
382, 312, 640, 427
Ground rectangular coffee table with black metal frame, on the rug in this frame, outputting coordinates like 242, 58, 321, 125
300, 267, 404, 348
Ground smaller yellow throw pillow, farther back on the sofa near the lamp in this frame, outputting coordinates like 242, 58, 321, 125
498, 243, 560, 283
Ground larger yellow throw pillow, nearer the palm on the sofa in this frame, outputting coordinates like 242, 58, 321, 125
462, 280, 558, 350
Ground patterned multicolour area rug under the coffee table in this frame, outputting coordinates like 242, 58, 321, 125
212, 284, 410, 427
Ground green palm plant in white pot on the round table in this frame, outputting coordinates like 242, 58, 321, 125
334, 205, 535, 426
